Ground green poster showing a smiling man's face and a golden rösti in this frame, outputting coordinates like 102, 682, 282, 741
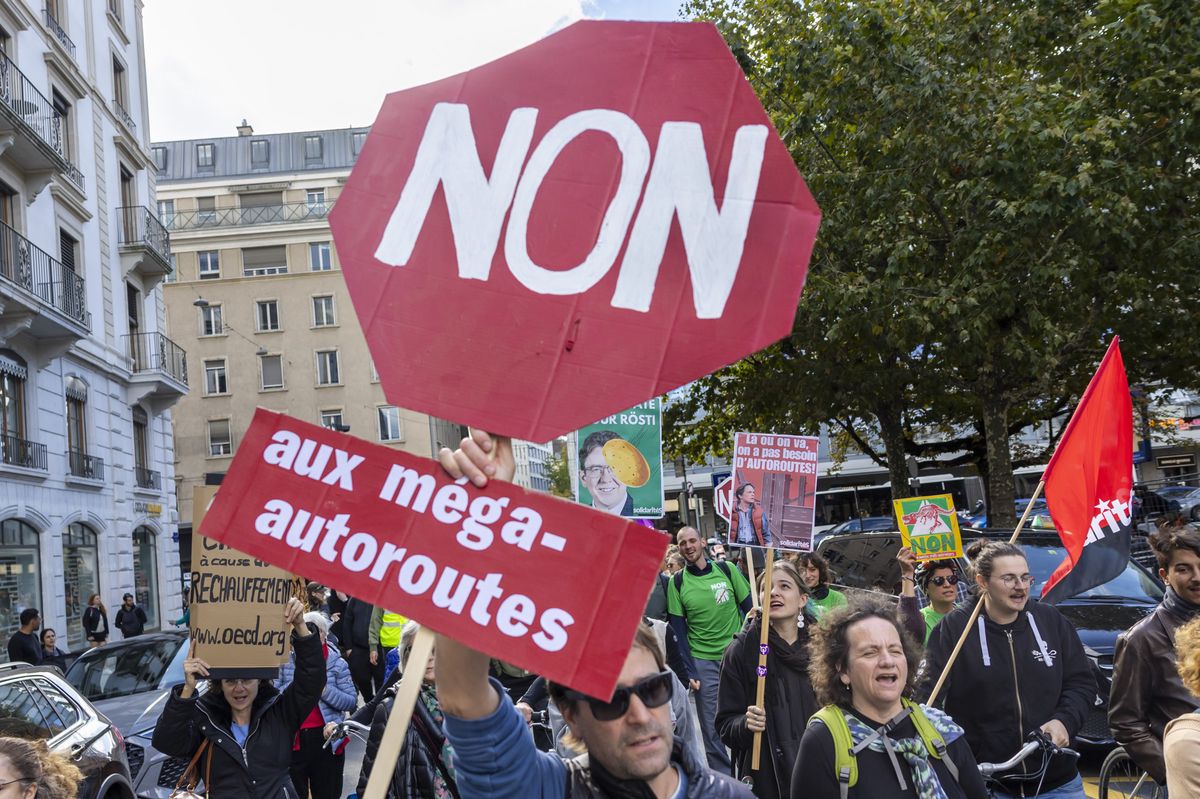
574, 397, 664, 518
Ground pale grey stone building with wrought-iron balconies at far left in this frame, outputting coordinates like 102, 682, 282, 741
0, 0, 187, 657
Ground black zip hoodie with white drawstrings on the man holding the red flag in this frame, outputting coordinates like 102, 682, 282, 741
922, 601, 1096, 797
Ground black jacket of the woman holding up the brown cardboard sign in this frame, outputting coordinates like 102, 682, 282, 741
152, 635, 325, 799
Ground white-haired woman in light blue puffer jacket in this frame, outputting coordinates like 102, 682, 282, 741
275, 611, 358, 799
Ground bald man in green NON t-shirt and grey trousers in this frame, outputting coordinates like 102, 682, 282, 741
667, 527, 752, 774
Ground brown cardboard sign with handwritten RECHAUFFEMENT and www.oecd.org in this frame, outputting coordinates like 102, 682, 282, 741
187, 486, 304, 679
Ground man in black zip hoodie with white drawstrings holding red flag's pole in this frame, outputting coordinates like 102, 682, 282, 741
925, 542, 1096, 799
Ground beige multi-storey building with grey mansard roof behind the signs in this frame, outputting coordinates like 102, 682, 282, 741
159, 122, 453, 551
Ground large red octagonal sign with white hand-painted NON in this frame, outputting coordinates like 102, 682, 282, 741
332, 22, 820, 441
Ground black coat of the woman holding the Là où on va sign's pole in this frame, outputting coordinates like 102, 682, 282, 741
716, 618, 818, 799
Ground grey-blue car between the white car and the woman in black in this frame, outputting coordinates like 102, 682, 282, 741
67, 632, 187, 799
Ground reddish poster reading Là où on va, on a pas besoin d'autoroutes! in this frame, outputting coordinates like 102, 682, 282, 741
728, 433, 818, 552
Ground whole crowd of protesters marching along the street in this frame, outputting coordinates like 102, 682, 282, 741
133, 433, 1200, 799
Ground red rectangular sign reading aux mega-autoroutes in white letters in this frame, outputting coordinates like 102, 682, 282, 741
200, 408, 667, 697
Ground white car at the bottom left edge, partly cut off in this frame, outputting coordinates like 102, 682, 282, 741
0, 663, 133, 799
